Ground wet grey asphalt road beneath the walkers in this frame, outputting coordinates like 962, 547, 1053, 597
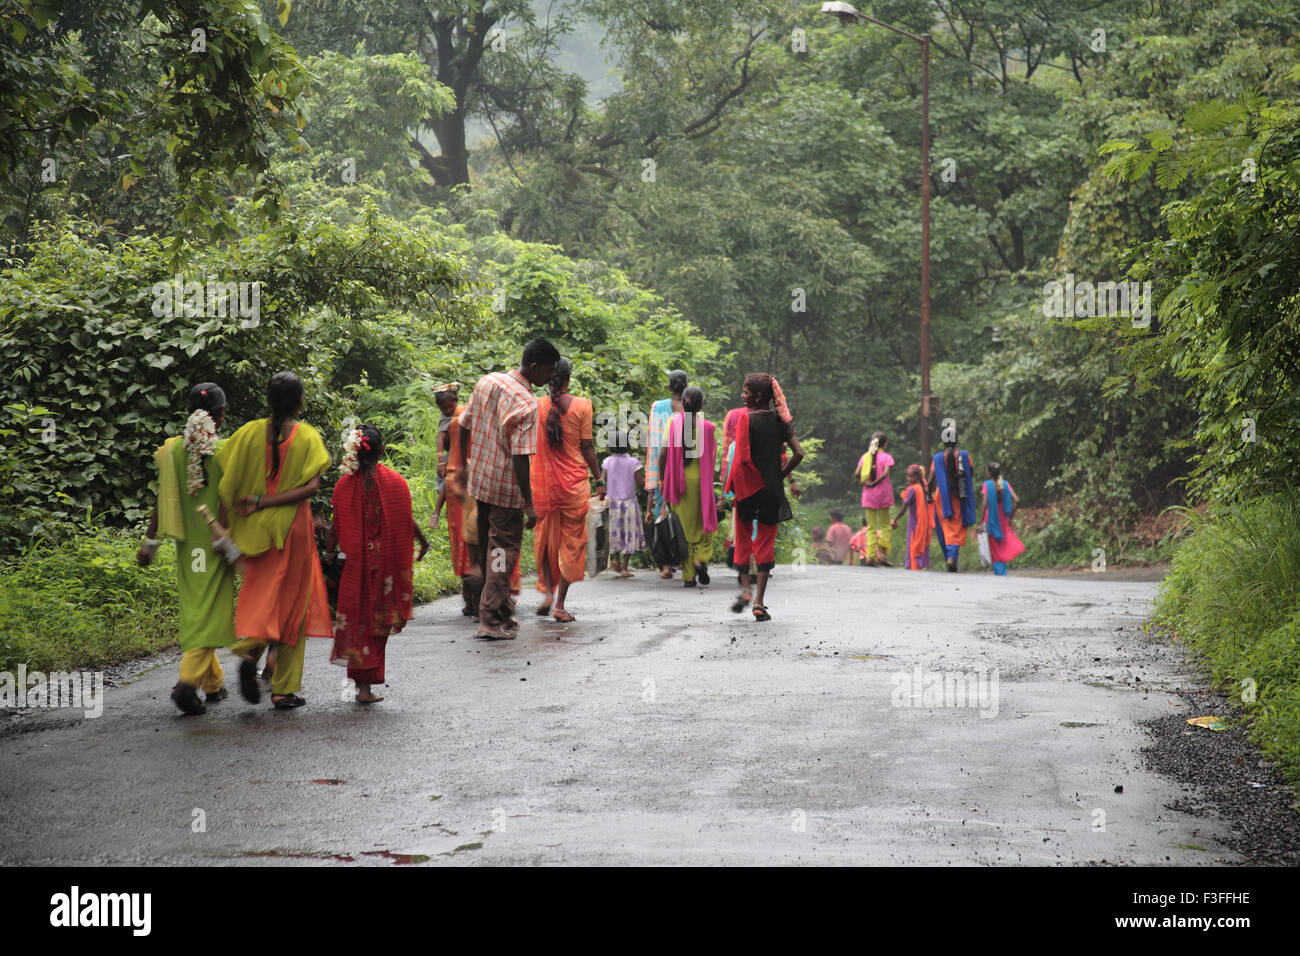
0, 567, 1240, 865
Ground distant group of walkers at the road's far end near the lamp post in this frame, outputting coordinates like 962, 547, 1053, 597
813, 432, 1024, 575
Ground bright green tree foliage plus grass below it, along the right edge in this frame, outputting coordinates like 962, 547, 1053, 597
1106, 46, 1300, 782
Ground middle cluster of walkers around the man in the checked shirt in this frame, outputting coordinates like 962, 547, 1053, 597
433, 356, 803, 629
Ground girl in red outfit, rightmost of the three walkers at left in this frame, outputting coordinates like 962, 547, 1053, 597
330, 425, 429, 704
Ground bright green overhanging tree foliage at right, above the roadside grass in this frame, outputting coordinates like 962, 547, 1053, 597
1110, 68, 1300, 498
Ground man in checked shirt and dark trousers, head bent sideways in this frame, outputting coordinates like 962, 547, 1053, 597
460, 338, 560, 640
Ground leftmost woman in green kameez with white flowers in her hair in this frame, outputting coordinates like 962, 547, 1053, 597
137, 382, 238, 714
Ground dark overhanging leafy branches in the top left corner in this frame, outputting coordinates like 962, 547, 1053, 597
0, 0, 308, 252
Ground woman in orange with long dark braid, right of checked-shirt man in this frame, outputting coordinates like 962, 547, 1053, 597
530, 359, 601, 622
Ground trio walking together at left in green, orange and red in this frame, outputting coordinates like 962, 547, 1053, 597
137, 372, 429, 714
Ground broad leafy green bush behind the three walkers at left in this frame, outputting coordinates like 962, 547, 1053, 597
0, 209, 478, 554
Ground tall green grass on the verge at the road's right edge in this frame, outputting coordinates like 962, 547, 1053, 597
1154, 494, 1300, 787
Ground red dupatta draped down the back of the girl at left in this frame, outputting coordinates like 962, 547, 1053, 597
332, 464, 415, 650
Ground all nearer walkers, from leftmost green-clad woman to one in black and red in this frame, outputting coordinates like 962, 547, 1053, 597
144, 339, 803, 714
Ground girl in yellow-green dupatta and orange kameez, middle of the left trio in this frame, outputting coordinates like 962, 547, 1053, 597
217, 372, 334, 710
